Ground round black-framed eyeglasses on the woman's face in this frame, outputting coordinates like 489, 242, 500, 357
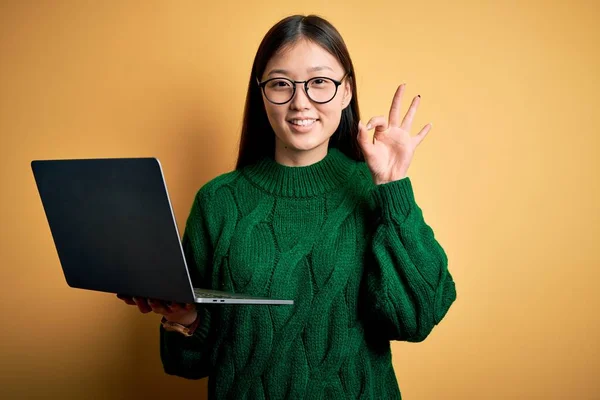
256, 73, 348, 105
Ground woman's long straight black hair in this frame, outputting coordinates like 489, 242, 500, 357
236, 15, 363, 169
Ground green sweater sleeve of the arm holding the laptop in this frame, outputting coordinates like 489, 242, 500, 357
159, 191, 212, 379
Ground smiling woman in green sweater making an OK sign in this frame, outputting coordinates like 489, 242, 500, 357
118, 16, 456, 399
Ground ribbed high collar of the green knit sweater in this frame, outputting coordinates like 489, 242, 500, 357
243, 148, 356, 198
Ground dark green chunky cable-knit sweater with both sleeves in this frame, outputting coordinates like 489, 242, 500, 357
160, 149, 456, 400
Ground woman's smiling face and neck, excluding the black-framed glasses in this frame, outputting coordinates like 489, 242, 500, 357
261, 40, 352, 166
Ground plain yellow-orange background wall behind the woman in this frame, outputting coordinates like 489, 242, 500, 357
0, 0, 600, 400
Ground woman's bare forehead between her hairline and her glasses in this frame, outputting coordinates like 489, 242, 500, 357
265, 40, 343, 75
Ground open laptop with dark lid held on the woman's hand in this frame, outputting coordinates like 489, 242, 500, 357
31, 157, 294, 305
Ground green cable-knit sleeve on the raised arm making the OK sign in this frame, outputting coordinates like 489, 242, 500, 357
365, 178, 456, 342
